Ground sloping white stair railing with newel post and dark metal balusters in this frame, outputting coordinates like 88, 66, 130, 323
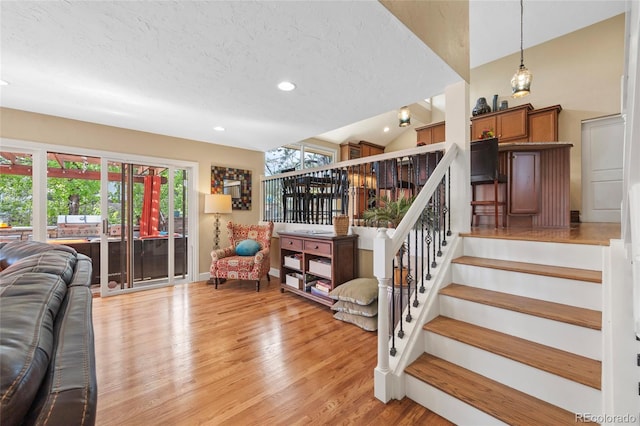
373, 144, 459, 402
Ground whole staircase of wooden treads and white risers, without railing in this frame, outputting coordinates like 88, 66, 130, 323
405, 237, 603, 425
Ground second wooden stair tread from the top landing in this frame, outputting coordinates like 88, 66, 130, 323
440, 284, 602, 330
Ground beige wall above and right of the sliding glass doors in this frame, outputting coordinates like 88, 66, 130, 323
0, 108, 264, 278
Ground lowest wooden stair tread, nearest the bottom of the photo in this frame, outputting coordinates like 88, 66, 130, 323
405, 353, 596, 425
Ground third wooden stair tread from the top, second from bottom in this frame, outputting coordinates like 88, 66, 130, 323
423, 316, 602, 390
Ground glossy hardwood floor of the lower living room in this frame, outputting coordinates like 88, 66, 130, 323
93, 280, 451, 426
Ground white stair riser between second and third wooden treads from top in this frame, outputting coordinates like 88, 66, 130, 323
439, 295, 602, 360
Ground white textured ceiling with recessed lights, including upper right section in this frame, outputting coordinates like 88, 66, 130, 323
0, 0, 624, 150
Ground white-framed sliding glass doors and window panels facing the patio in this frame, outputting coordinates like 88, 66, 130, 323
0, 139, 197, 295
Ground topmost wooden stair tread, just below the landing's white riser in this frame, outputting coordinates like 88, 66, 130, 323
451, 256, 602, 284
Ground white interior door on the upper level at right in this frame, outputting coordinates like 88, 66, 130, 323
580, 115, 624, 222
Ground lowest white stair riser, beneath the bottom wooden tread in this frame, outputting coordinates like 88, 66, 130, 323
405, 374, 506, 426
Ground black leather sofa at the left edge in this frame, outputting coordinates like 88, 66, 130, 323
0, 241, 97, 426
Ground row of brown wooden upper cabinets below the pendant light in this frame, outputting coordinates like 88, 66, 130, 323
471, 104, 562, 142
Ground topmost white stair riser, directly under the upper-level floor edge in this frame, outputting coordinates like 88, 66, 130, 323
463, 237, 603, 271
